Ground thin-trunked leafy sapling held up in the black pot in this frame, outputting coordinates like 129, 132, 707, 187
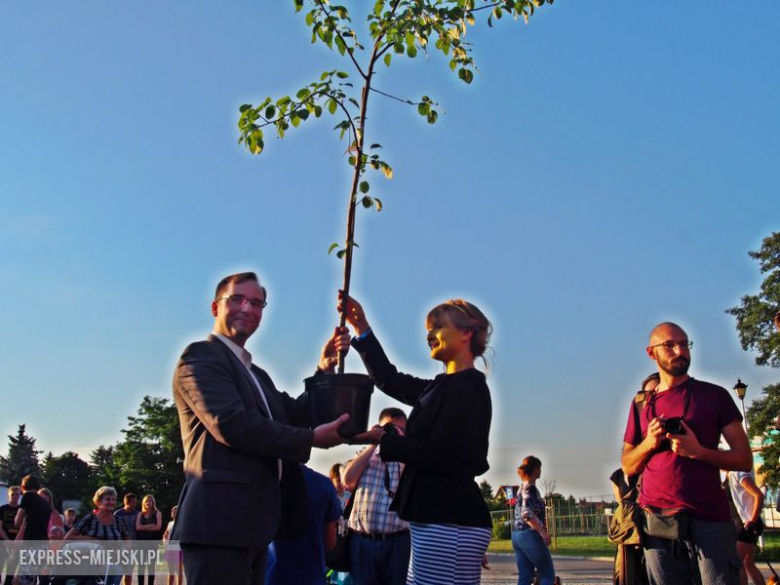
238, 0, 553, 372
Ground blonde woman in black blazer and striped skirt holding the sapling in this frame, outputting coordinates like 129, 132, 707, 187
339, 297, 492, 585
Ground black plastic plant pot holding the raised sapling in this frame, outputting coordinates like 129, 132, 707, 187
304, 374, 374, 438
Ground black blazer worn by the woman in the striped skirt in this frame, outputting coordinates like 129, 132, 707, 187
352, 333, 492, 527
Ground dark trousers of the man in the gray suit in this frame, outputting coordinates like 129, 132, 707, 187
181, 543, 268, 585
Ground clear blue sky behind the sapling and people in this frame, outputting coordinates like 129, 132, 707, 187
0, 0, 780, 495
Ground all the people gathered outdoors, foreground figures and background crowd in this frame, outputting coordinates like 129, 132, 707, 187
0, 272, 780, 585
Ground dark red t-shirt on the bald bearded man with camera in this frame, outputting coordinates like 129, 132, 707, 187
623, 380, 742, 522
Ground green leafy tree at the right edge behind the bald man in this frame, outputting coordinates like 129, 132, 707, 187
726, 232, 780, 488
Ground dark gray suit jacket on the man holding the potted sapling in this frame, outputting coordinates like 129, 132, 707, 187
172, 335, 313, 548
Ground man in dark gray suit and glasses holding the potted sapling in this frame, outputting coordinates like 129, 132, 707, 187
171, 272, 349, 585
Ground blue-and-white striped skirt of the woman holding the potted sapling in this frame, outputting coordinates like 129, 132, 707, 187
406, 522, 492, 585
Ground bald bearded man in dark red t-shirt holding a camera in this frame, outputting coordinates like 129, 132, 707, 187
622, 323, 753, 585
